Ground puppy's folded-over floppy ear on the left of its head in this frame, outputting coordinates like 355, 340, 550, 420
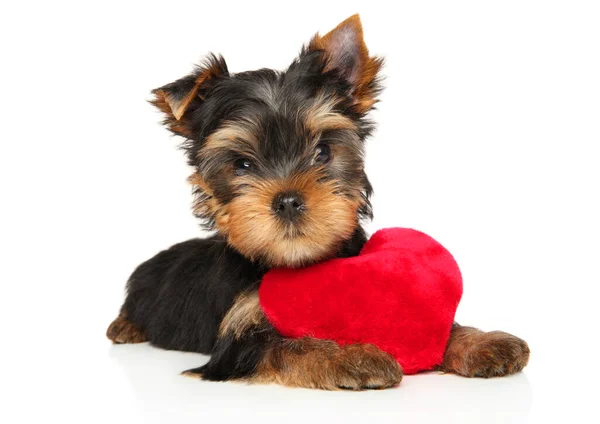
150, 54, 229, 138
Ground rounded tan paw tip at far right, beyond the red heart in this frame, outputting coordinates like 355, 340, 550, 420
458, 331, 529, 378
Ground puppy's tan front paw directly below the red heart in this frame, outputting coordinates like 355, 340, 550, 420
328, 344, 402, 390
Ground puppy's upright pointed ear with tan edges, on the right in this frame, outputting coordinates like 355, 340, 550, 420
308, 14, 383, 113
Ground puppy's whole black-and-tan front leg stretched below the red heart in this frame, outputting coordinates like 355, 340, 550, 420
184, 292, 402, 390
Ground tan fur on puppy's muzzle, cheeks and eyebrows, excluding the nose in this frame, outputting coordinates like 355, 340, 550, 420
188, 111, 365, 266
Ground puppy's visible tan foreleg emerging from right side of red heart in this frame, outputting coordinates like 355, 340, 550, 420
439, 324, 529, 378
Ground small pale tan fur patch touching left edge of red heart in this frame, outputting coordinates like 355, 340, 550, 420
219, 291, 265, 339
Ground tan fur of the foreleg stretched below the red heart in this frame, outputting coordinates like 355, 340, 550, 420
250, 337, 402, 390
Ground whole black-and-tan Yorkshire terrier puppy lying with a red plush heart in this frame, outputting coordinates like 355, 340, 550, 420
107, 15, 529, 390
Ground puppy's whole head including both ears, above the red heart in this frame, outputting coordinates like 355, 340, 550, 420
153, 16, 381, 267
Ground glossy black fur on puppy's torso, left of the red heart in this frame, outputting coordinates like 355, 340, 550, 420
123, 236, 265, 353
